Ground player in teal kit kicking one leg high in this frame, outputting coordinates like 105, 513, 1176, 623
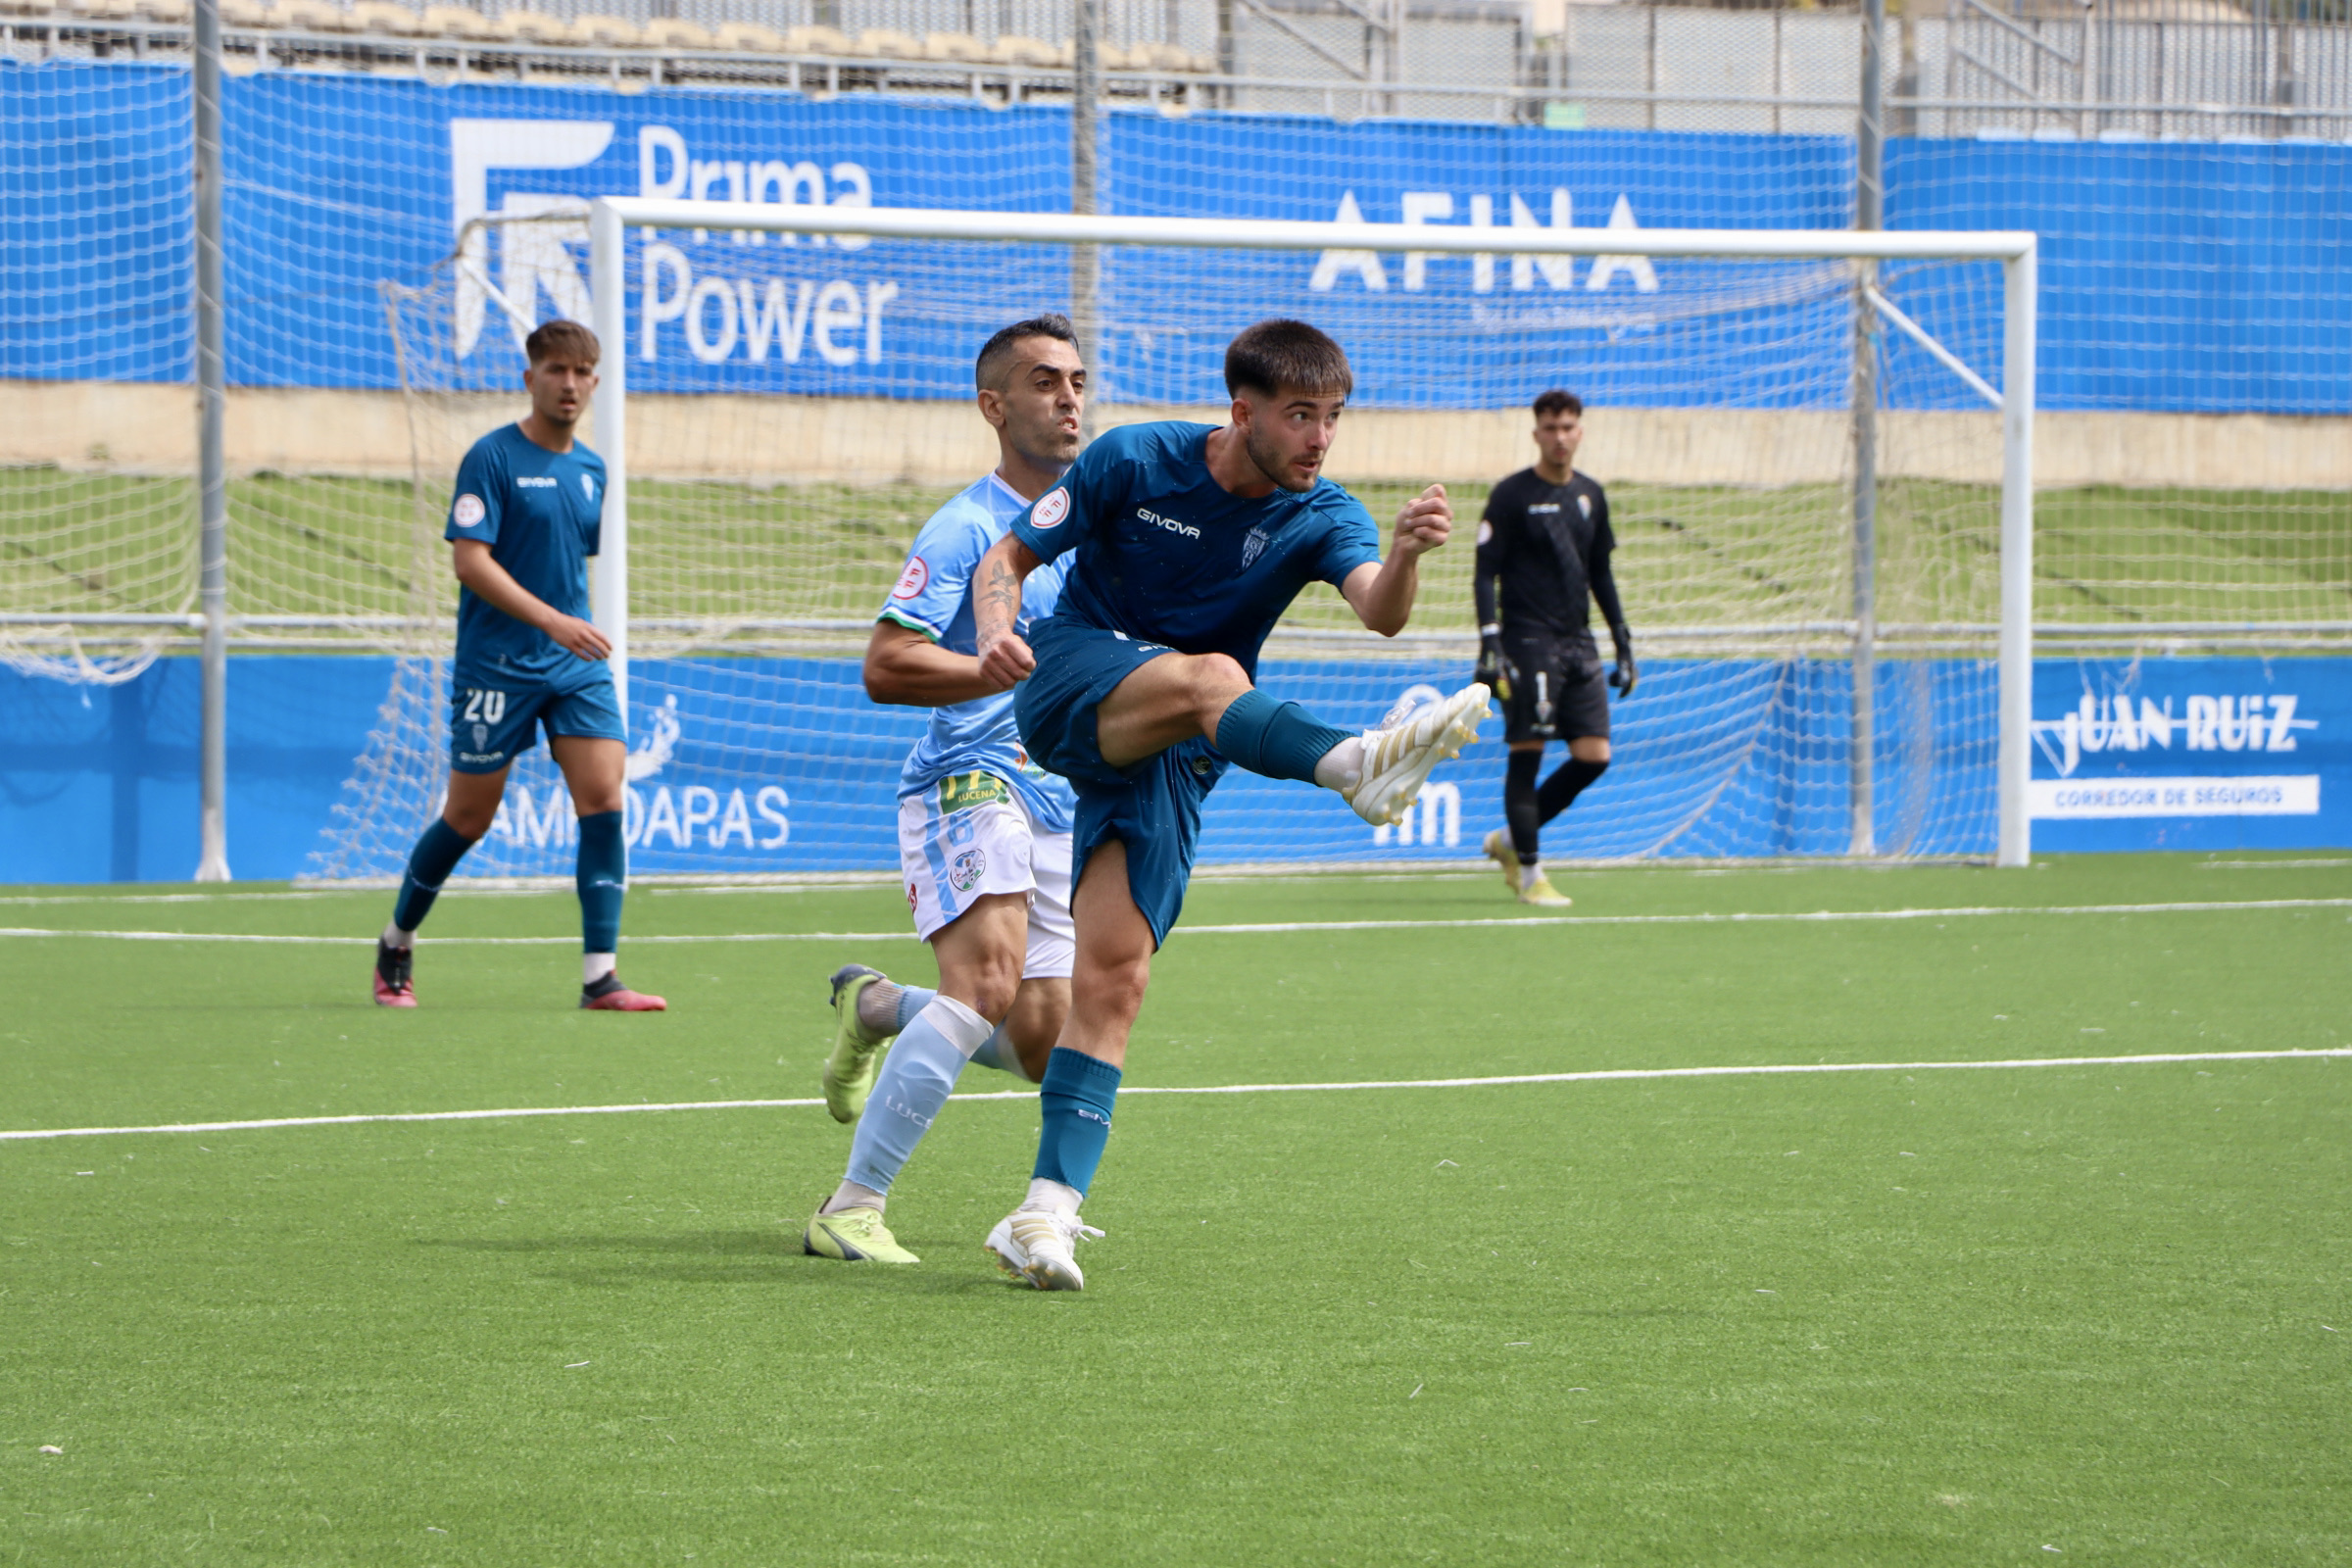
974, 319, 1487, 1291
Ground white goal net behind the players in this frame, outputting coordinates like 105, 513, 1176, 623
318, 193, 2033, 877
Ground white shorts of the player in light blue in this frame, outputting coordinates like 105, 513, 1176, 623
899, 773, 1077, 980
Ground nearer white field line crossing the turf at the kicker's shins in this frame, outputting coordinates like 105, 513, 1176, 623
0, 1046, 2352, 1143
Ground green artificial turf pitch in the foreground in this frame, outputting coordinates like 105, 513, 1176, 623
0, 856, 2352, 1566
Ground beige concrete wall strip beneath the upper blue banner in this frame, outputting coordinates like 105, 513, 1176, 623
0, 381, 2352, 489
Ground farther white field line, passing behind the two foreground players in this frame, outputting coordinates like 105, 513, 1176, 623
0, 898, 2352, 948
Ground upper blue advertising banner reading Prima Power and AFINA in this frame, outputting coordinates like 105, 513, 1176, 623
0, 61, 2352, 414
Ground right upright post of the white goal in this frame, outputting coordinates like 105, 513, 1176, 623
1999, 244, 2039, 865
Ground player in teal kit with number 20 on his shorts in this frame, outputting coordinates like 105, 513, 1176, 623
376, 322, 665, 1013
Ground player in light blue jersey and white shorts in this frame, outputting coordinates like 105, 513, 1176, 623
800, 315, 1087, 1262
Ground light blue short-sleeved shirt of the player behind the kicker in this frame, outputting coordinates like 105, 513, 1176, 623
877, 472, 1075, 832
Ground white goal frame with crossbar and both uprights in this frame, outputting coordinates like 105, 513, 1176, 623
578, 197, 2036, 865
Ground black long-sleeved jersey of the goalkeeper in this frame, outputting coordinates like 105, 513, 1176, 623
1475, 467, 1625, 637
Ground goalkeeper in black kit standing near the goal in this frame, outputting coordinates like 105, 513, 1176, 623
1472, 390, 1640, 907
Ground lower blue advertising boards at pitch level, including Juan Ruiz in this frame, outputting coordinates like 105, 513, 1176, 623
0, 656, 2352, 882
